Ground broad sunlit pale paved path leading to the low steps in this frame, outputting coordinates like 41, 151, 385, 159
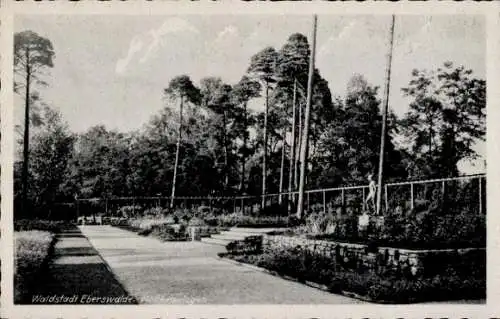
80, 226, 361, 304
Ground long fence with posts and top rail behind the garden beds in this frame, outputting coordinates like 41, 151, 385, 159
74, 174, 486, 216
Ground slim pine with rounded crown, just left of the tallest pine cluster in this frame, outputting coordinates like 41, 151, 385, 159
248, 47, 278, 208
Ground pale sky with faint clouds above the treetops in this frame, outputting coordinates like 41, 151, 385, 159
15, 15, 486, 174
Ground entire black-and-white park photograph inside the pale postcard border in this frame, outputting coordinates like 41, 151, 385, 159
10, 12, 489, 306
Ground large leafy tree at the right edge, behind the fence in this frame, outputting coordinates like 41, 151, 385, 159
400, 62, 486, 177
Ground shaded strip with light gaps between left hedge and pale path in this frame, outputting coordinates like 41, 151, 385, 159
22, 227, 137, 305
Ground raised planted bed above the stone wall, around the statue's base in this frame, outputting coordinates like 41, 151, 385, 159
296, 210, 486, 250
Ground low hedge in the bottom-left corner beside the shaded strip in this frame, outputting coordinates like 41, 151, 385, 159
14, 230, 54, 302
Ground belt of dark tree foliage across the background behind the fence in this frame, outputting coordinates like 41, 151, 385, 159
15, 33, 485, 222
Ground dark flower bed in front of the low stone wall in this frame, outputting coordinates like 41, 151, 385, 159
220, 248, 486, 304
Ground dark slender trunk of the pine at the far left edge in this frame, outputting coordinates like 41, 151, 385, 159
21, 55, 31, 217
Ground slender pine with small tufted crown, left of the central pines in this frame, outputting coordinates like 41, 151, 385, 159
164, 75, 200, 207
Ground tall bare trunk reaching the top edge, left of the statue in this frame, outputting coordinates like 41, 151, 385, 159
297, 15, 318, 219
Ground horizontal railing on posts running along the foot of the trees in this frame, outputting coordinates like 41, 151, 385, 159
70, 174, 486, 219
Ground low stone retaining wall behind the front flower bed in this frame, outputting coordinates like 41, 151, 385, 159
262, 235, 486, 275
